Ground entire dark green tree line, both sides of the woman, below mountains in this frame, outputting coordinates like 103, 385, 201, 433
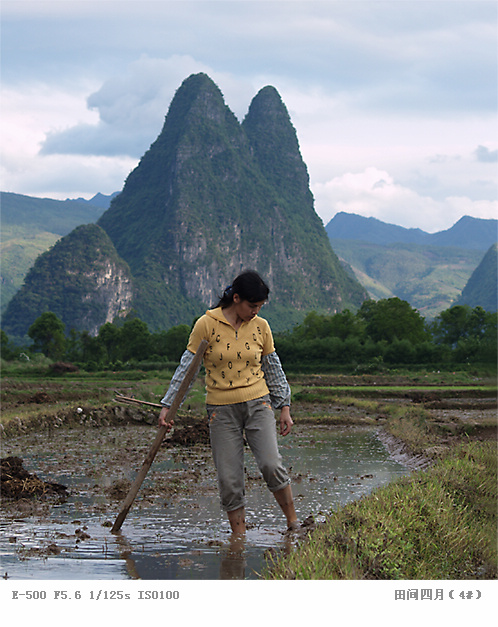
1, 298, 497, 371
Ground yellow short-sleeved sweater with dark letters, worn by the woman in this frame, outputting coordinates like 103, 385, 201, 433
187, 307, 275, 405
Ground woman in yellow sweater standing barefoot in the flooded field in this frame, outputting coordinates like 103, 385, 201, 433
159, 271, 299, 534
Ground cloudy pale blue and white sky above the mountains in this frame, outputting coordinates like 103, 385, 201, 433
0, 0, 498, 232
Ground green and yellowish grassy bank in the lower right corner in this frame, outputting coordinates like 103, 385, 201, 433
264, 442, 497, 580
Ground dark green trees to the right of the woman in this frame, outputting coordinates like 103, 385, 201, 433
276, 298, 497, 371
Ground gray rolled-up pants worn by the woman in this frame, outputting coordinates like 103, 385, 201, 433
207, 396, 290, 512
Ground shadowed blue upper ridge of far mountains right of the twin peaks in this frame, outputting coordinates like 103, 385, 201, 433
325, 212, 498, 250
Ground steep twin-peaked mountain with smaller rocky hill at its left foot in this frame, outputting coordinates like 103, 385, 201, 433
3, 74, 367, 336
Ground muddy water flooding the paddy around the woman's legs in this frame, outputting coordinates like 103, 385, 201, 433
0, 426, 408, 580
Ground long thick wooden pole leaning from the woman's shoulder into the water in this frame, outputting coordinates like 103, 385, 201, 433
111, 340, 208, 533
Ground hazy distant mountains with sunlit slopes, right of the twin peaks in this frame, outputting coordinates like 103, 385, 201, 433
326, 213, 498, 318
